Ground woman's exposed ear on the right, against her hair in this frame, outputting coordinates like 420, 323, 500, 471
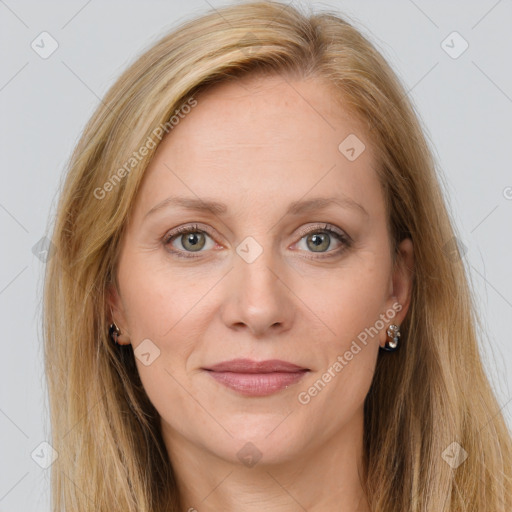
381, 238, 414, 345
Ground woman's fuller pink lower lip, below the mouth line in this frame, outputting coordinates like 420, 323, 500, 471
208, 370, 307, 396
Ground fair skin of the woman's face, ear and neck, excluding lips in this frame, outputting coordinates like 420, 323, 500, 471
111, 76, 414, 512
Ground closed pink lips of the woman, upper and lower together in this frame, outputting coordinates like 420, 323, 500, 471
203, 359, 310, 396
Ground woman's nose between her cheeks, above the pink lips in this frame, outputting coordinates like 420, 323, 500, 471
221, 242, 295, 337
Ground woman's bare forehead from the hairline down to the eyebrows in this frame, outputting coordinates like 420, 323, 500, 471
132, 76, 377, 220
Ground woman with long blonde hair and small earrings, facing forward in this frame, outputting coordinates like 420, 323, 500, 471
45, 2, 512, 512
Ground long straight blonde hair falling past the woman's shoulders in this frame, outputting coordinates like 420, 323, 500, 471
44, 1, 512, 512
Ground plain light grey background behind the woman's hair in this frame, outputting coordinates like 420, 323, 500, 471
0, 0, 512, 512
